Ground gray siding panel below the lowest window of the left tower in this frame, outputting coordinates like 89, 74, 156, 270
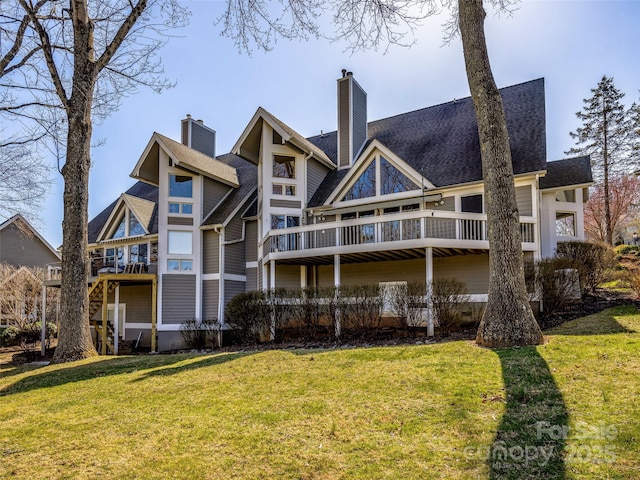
162, 275, 196, 324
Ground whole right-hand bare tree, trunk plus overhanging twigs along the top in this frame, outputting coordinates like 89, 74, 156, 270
220, 0, 542, 347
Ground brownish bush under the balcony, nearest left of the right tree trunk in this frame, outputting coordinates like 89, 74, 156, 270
431, 278, 469, 335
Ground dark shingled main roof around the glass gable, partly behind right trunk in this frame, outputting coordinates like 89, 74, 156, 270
309, 79, 546, 207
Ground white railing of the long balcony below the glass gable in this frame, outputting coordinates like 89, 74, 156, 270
264, 211, 536, 254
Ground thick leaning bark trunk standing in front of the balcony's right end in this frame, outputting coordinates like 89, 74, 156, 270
458, 0, 543, 347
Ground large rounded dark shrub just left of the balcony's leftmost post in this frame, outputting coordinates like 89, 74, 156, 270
224, 291, 271, 343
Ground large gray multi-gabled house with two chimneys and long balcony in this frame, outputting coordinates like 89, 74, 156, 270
82, 71, 592, 350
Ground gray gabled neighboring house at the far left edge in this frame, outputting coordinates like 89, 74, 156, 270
0, 214, 60, 326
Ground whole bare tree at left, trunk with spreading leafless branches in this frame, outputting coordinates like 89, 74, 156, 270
0, 0, 188, 362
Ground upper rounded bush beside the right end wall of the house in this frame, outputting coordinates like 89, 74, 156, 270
556, 242, 615, 295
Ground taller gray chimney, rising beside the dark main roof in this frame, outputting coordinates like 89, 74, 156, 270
338, 69, 368, 169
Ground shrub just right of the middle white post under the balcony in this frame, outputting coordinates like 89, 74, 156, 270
338, 285, 383, 334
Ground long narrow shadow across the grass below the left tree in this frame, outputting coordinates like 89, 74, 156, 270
0, 352, 252, 397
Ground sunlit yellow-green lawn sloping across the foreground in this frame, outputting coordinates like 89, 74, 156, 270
0, 308, 640, 479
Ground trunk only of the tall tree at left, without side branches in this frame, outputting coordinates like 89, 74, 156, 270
53, 0, 98, 363
